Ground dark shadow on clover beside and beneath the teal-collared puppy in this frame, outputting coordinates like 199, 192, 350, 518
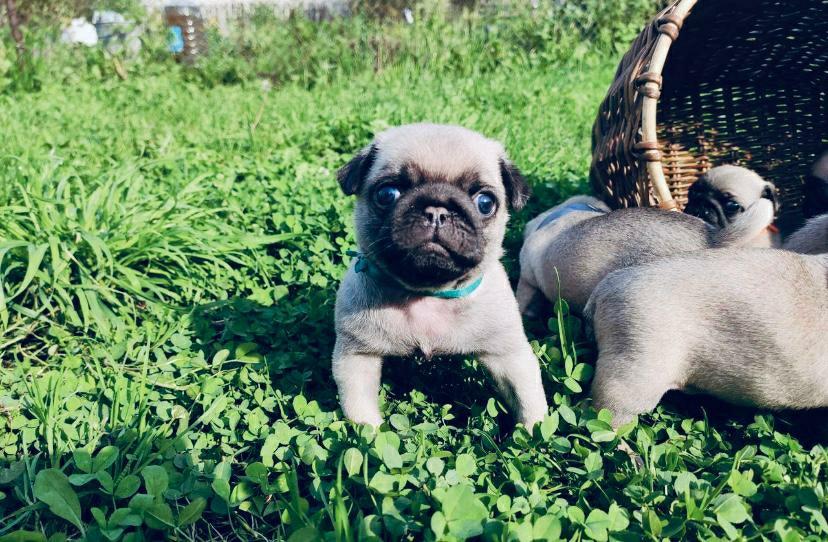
191, 296, 516, 432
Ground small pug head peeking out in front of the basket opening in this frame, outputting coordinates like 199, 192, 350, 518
684, 165, 779, 228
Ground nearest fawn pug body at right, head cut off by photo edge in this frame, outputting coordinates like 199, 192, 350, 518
585, 248, 828, 427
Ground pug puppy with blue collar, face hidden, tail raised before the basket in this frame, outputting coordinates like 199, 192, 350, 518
517, 196, 773, 318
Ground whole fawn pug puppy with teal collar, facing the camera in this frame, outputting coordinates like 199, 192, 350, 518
333, 124, 546, 427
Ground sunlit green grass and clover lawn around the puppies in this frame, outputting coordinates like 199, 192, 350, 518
0, 5, 828, 542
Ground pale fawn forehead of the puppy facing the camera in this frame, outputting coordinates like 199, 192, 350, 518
369, 126, 504, 185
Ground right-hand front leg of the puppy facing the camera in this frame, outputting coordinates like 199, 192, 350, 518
480, 340, 547, 431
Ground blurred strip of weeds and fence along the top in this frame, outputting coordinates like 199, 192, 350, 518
0, 0, 663, 92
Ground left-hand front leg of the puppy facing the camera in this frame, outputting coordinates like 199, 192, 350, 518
333, 345, 382, 427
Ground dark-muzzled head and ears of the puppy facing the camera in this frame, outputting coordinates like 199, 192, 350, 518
337, 124, 529, 290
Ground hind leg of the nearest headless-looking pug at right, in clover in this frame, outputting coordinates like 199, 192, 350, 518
591, 354, 675, 429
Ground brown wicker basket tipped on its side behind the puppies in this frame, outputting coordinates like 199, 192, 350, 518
590, 0, 828, 229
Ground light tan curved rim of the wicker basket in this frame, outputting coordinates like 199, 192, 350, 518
635, 0, 698, 210
